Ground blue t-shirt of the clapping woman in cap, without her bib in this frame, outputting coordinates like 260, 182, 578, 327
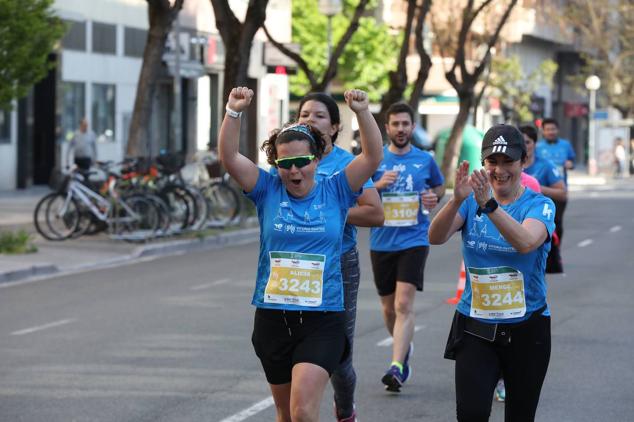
457, 189, 555, 323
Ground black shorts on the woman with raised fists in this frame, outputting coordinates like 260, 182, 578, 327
251, 308, 349, 385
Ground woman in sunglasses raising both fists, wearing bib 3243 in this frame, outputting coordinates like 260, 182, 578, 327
219, 87, 383, 421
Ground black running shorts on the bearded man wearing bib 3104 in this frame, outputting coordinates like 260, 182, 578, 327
370, 246, 429, 296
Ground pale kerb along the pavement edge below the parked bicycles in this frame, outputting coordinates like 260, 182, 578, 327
0, 228, 260, 285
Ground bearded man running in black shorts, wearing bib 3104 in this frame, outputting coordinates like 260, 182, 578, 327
370, 103, 444, 392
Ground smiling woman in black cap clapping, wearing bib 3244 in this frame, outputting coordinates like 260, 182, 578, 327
429, 125, 555, 422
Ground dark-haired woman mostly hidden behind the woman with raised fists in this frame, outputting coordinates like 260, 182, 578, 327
271, 92, 384, 422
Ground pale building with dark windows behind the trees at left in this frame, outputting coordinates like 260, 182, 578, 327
0, 0, 291, 190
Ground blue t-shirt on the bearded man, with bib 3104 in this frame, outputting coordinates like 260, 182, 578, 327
370, 146, 445, 252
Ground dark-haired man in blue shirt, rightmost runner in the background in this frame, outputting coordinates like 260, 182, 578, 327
535, 118, 575, 273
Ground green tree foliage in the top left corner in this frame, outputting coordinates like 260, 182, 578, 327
0, 0, 65, 110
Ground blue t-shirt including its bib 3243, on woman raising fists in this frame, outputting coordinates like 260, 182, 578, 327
246, 169, 361, 311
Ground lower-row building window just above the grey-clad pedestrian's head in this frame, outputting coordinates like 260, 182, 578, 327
57, 82, 86, 141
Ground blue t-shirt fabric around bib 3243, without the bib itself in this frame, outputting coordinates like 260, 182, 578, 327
247, 169, 360, 311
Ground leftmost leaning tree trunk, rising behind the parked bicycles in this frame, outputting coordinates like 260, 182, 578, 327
126, 0, 184, 157
